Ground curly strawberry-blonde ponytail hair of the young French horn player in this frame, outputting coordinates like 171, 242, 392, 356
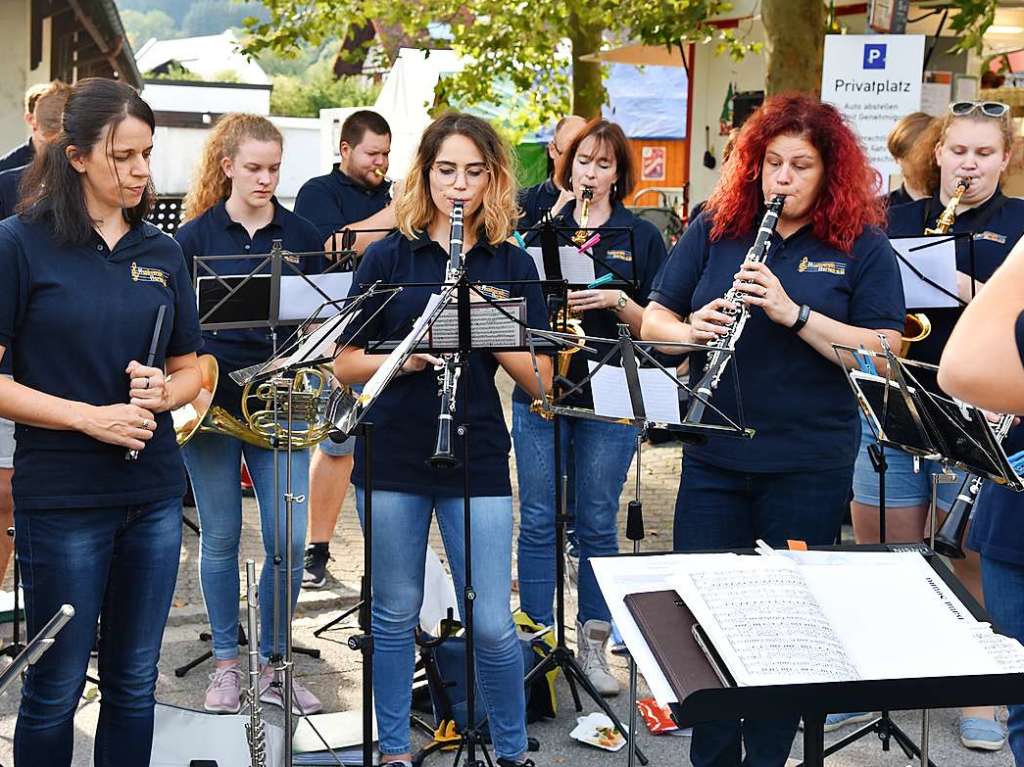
181, 112, 285, 223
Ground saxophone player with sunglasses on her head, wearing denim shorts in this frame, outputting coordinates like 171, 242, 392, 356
847, 101, 1024, 751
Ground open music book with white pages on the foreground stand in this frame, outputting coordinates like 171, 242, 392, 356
670, 552, 1024, 686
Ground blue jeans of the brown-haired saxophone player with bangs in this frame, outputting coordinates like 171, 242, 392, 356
512, 400, 637, 626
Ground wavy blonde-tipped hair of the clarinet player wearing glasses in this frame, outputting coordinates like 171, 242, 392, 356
395, 112, 519, 245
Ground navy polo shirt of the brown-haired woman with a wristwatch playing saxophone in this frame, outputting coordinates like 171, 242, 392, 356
513, 201, 668, 409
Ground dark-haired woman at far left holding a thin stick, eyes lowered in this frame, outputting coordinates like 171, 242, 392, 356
0, 78, 202, 767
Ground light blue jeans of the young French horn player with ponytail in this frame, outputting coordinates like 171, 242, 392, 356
182, 434, 309, 661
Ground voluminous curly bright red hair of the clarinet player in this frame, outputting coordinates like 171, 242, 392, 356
707, 93, 886, 253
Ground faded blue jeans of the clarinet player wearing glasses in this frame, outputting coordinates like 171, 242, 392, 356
355, 487, 526, 759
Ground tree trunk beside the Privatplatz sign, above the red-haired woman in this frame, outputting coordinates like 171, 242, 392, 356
761, 0, 825, 96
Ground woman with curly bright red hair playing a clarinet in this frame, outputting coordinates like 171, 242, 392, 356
642, 94, 904, 767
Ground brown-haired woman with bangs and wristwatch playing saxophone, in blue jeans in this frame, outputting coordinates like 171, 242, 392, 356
512, 119, 666, 695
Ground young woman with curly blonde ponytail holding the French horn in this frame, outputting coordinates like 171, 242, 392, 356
176, 114, 323, 714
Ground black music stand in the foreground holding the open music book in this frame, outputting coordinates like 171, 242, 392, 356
614, 545, 1022, 767
